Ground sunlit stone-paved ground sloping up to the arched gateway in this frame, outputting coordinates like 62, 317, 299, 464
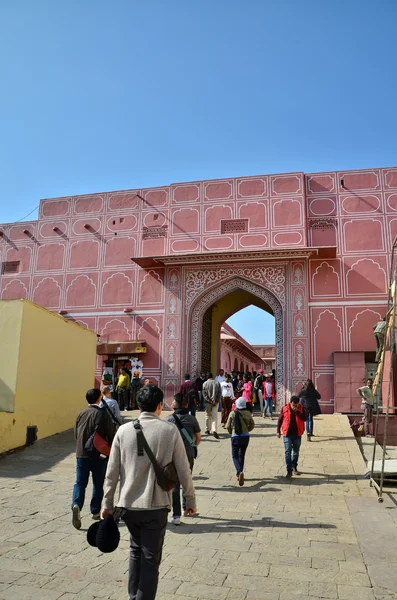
0, 414, 397, 600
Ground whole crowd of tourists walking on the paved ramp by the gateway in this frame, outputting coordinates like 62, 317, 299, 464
72, 372, 321, 600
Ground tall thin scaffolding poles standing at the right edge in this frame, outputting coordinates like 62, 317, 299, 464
370, 237, 397, 502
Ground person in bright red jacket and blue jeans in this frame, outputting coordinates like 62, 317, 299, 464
277, 396, 307, 478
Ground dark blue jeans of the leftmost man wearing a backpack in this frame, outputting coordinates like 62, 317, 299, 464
72, 458, 108, 515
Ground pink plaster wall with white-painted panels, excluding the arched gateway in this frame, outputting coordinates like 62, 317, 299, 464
0, 168, 397, 411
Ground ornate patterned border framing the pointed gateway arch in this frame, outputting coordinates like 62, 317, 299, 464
187, 277, 286, 400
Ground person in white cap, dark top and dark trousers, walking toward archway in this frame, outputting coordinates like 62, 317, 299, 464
226, 398, 255, 485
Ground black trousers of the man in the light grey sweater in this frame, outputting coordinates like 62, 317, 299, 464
122, 508, 168, 600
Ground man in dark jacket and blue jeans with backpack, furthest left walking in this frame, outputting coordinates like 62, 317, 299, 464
72, 389, 116, 529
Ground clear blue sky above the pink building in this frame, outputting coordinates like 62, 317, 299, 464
0, 0, 397, 342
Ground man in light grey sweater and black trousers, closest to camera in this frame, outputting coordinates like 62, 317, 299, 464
101, 385, 197, 600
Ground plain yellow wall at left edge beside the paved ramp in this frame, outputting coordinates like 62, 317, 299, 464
0, 300, 96, 453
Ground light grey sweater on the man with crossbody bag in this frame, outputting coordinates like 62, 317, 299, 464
103, 412, 196, 510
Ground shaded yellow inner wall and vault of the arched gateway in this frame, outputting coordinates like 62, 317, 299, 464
211, 290, 272, 374
